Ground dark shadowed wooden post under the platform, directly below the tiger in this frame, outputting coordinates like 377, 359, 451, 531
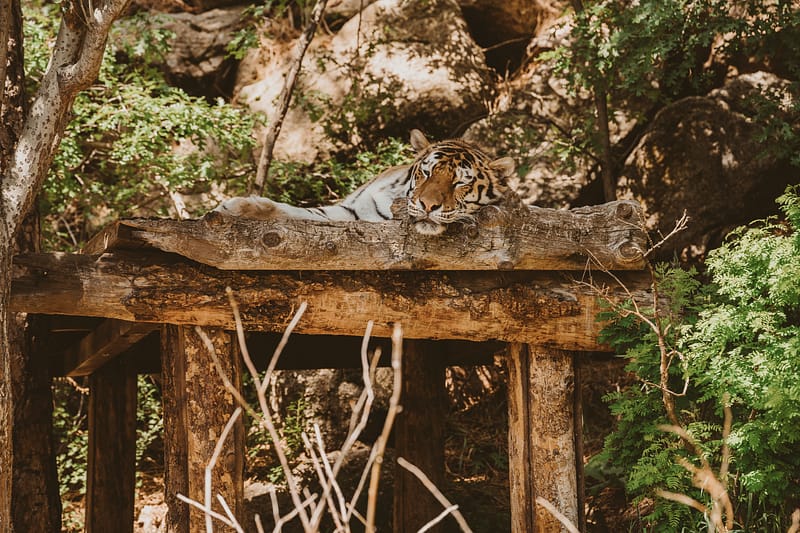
393, 340, 447, 532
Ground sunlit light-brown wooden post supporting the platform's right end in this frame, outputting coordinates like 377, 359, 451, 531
508, 343, 579, 533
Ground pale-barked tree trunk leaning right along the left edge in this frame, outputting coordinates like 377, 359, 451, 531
0, 0, 128, 531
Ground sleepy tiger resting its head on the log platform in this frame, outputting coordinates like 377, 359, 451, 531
214, 129, 515, 236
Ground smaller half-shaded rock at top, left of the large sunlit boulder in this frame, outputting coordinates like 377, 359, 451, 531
155, 7, 244, 97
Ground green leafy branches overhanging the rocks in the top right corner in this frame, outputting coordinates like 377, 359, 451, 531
541, 0, 800, 164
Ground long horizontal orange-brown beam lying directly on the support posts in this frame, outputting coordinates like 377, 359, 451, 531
11, 252, 650, 351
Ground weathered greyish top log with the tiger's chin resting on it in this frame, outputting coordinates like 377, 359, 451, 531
84, 200, 647, 270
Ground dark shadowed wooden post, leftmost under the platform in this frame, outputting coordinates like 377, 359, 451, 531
86, 357, 136, 533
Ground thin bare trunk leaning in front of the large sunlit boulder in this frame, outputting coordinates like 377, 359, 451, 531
253, 0, 328, 195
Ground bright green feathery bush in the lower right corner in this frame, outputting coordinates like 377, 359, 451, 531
595, 187, 800, 531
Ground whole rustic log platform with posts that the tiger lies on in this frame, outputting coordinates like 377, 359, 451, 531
11, 201, 649, 532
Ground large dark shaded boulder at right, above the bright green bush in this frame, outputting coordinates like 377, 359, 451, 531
618, 72, 800, 261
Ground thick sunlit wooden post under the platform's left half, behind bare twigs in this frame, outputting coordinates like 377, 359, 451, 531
161, 326, 245, 533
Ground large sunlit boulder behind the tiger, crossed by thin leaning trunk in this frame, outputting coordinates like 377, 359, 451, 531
235, 0, 492, 162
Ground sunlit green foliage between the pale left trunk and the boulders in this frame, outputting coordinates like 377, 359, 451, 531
25, 6, 255, 248
